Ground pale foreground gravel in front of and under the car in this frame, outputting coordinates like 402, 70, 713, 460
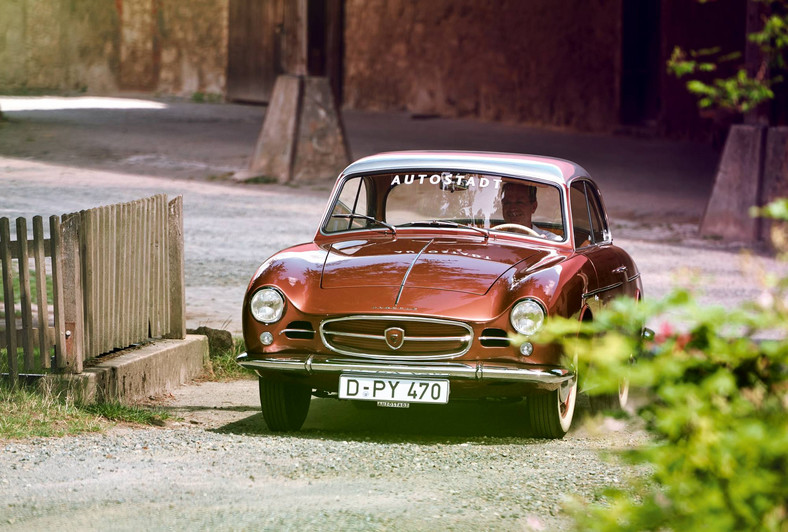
0, 381, 645, 531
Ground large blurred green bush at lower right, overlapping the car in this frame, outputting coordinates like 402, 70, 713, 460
540, 200, 788, 531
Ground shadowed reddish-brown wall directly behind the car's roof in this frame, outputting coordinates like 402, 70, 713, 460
344, 0, 620, 130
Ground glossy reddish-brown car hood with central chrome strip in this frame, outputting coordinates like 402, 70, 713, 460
321, 238, 550, 295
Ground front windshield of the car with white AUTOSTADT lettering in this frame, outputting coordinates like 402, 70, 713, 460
323, 171, 566, 241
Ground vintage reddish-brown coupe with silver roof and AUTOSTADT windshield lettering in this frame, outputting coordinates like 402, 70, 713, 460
238, 152, 642, 438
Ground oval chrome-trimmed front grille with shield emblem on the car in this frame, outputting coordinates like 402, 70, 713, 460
320, 316, 473, 360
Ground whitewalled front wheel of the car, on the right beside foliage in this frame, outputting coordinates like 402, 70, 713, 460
528, 377, 577, 439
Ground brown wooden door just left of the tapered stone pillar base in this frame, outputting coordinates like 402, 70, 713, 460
227, 0, 285, 103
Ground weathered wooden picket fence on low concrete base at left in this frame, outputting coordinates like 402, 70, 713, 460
0, 195, 186, 382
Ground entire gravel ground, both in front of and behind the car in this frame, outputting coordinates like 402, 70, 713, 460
0, 97, 783, 530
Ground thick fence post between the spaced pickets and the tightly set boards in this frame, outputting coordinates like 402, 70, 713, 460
59, 213, 85, 373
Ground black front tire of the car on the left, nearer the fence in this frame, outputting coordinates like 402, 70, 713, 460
259, 377, 312, 432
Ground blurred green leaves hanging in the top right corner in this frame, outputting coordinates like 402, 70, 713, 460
667, 0, 788, 113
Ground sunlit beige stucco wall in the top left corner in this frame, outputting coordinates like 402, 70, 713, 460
0, 0, 229, 96
